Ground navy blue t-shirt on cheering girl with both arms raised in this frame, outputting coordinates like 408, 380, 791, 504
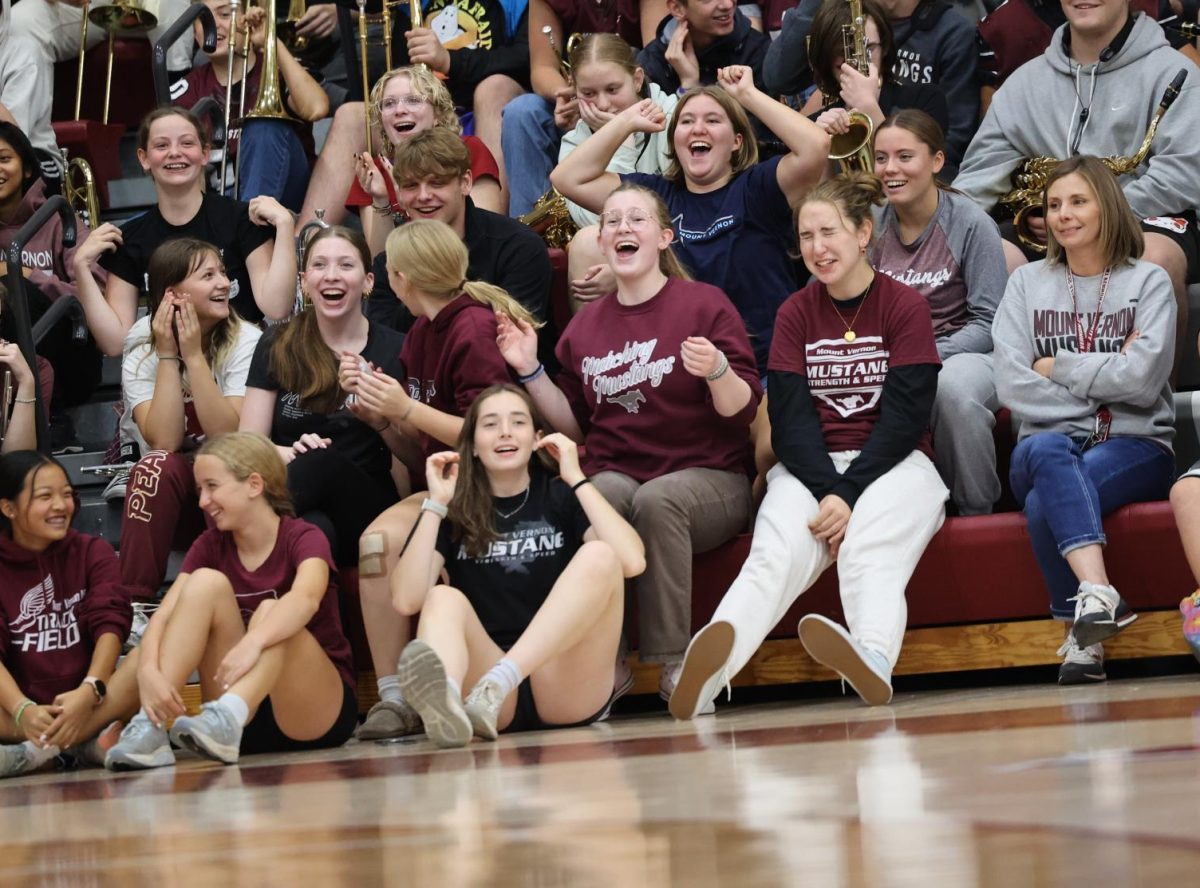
620, 157, 797, 373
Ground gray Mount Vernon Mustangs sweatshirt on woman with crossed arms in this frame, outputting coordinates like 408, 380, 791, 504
991, 260, 1175, 449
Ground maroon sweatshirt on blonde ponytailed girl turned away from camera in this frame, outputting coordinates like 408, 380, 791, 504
400, 293, 512, 456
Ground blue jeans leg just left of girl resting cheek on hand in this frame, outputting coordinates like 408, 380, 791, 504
500, 92, 563, 216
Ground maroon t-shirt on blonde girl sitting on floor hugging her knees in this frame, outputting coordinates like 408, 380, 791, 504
180, 517, 358, 688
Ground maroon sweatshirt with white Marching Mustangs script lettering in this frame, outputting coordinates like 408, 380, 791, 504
557, 277, 762, 481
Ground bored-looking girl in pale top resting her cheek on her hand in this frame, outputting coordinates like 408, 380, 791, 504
558, 34, 679, 311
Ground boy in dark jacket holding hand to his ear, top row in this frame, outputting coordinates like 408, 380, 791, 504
637, 0, 780, 97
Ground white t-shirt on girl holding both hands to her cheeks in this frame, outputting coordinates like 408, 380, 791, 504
121, 314, 263, 455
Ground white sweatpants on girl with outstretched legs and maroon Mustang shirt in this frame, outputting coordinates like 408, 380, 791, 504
713, 450, 949, 677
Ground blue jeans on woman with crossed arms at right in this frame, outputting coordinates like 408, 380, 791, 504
1009, 432, 1175, 620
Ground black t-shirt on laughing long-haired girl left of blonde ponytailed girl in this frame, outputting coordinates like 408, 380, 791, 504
246, 323, 404, 479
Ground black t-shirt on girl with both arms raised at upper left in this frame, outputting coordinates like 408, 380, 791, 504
100, 192, 275, 324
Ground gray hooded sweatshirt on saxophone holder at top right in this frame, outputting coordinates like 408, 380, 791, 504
954, 13, 1200, 217
